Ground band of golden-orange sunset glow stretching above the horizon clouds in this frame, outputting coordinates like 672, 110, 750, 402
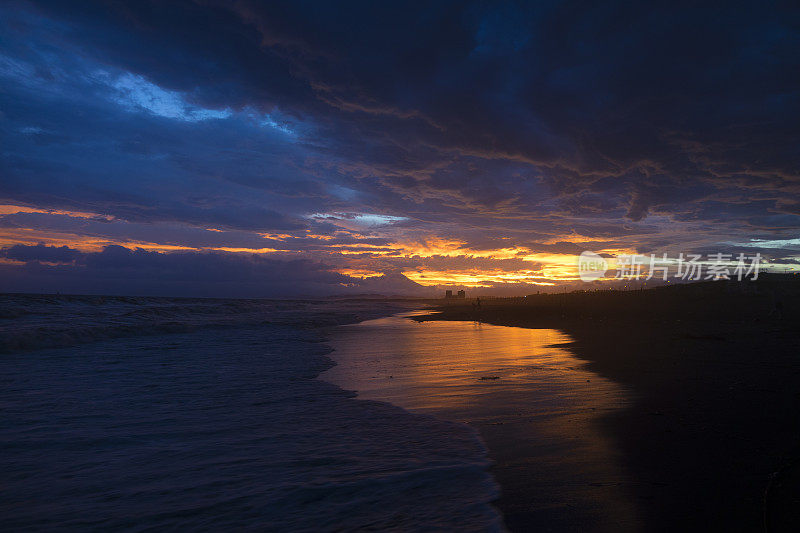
0, 204, 788, 292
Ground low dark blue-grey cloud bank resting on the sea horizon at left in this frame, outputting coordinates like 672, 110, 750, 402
0, 246, 374, 297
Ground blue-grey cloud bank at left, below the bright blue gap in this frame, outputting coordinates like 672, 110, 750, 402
0, 64, 324, 230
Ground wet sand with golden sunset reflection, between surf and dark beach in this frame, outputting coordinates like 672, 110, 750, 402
321, 311, 639, 531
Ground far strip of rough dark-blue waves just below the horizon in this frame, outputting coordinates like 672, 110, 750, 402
0, 294, 400, 353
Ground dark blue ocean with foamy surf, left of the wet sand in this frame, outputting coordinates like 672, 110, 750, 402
0, 295, 503, 531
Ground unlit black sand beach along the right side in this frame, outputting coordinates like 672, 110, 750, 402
417, 279, 800, 531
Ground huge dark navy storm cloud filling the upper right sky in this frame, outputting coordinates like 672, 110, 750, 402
6, 2, 800, 225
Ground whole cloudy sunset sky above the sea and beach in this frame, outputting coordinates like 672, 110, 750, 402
0, 0, 800, 297
